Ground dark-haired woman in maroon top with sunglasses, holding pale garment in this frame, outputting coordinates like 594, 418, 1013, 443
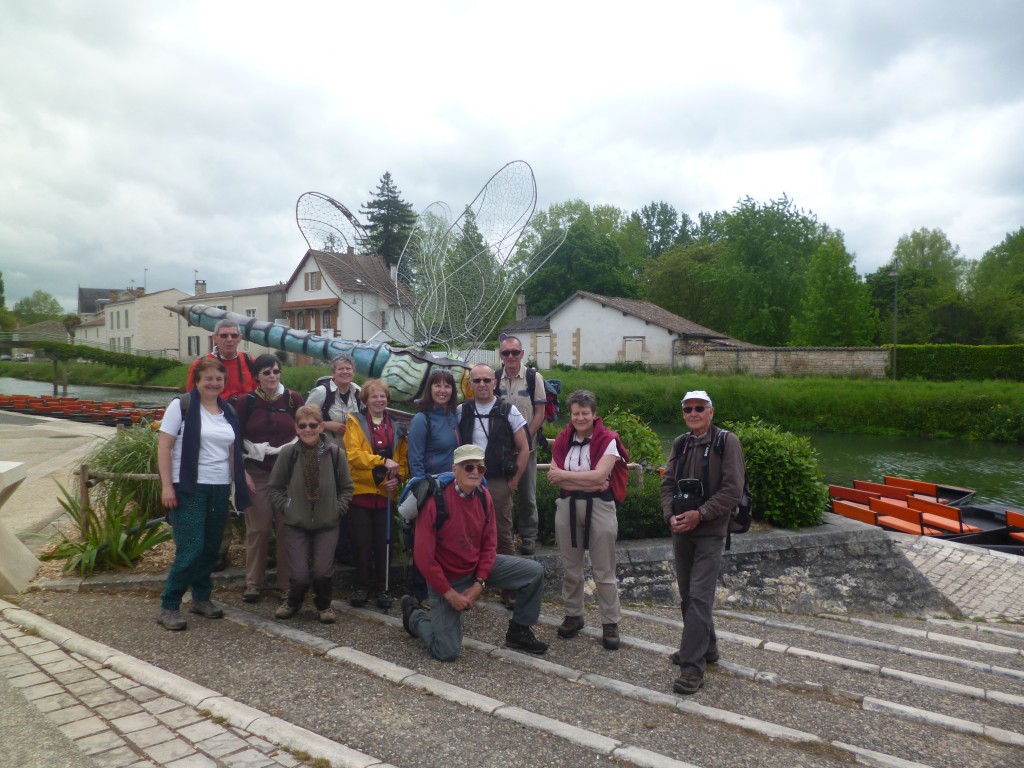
236, 354, 303, 603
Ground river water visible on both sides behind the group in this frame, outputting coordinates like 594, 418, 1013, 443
0, 377, 1024, 509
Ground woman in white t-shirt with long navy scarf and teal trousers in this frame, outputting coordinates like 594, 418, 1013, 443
157, 357, 249, 630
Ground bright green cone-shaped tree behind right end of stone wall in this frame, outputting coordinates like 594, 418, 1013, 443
790, 234, 879, 347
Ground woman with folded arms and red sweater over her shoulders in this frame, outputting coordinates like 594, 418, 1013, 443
548, 389, 627, 650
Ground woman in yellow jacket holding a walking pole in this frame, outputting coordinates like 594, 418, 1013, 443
345, 379, 409, 610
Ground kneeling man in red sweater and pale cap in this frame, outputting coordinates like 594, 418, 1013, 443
401, 443, 548, 662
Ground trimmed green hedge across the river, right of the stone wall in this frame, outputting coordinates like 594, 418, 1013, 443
896, 344, 1024, 381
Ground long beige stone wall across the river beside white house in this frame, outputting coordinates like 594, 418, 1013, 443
705, 347, 889, 379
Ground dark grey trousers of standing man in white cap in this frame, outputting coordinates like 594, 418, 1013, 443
672, 534, 725, 677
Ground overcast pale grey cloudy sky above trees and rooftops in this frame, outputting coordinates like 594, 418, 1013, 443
0, 0, 1024, 310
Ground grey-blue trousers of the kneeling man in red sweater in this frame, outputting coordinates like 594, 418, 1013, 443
409, 555, 544, 662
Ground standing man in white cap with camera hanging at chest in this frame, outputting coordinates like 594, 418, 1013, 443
662, 389, 745, 693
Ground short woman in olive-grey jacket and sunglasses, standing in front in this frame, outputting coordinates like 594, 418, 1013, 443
267, 406, 353, 624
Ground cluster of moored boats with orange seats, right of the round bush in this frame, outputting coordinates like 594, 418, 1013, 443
828, 475, 1024, 555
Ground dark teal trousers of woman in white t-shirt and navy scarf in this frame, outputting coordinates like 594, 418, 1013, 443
160, 483, 231, 610
